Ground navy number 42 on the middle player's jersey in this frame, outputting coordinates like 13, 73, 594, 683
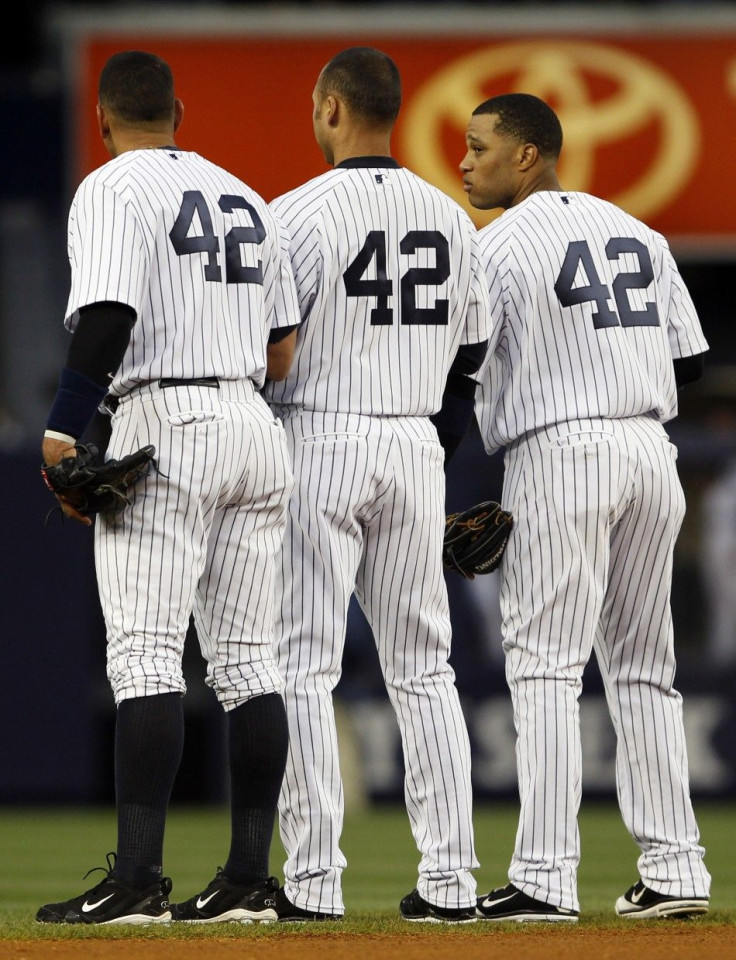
342, 230, 450, 326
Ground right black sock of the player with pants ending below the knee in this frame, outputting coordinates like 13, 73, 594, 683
224, 693, 289, 884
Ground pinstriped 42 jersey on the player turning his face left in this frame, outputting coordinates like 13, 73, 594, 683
478, 191, 708, 452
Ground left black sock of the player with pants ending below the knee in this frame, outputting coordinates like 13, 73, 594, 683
113, 693, 184, 887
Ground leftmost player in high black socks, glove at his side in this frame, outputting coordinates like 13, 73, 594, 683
37, 51, 299, 924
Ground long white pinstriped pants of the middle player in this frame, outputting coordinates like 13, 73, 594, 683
276, 407, 477, 914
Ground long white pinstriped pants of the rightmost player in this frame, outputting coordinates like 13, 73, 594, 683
501, 417, 710, 910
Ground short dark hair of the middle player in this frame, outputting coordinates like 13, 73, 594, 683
319, 47, 401, 126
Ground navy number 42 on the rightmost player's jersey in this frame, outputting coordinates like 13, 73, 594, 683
555, 237, 659, 329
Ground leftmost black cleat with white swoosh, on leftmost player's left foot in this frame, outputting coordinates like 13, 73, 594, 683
36, 854, 171, 926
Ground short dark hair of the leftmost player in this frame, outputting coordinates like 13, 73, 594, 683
98, 50, 174, 123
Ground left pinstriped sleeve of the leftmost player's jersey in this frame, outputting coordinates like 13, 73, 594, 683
65, 177, 148, 328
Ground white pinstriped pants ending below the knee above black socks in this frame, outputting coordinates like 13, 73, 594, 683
95, 380, 293, 710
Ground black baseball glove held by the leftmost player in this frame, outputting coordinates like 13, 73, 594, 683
41, 443, 156, 516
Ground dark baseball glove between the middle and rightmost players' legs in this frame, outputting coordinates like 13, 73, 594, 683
442, 500, 514, 580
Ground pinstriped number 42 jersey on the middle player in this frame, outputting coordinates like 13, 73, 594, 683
266, 166, 490, 416
